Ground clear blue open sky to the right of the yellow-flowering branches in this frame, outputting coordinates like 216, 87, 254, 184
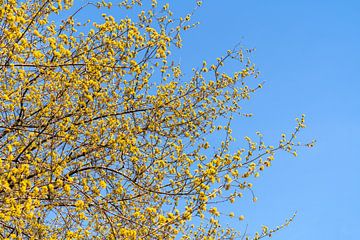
170, 0, 360, 240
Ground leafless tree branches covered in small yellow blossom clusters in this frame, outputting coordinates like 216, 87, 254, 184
0, 0, 312, 239
